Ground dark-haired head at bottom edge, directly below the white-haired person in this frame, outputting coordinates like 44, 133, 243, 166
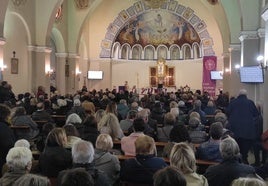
59, 168, 95, 186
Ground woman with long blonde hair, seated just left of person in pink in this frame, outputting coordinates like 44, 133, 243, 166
98, 113, 124, 140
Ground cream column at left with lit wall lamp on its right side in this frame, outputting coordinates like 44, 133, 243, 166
28, 46, 51, 94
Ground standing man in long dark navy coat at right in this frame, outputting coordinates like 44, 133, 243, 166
226, 89, 258, 164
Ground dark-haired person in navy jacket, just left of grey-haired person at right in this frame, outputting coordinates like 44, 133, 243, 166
196, 122, 223, 162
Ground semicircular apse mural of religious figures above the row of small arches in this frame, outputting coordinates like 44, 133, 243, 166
115, 10, 201, 47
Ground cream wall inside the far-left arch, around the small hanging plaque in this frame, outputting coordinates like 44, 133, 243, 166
4, 13, 31, 94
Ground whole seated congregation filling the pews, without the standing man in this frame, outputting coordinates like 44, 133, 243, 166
0, 82, 268, 186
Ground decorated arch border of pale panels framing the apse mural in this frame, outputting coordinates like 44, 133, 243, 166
100, 1, 215, 58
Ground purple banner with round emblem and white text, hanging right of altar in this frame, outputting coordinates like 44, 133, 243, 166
202, 56, 217, 96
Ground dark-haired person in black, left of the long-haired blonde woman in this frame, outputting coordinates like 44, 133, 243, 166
79, 115, 100, 147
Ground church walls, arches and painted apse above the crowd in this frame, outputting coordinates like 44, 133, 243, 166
0, 0, 268, 131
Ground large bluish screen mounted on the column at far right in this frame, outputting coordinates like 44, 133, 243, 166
239, 66, 264, 83
